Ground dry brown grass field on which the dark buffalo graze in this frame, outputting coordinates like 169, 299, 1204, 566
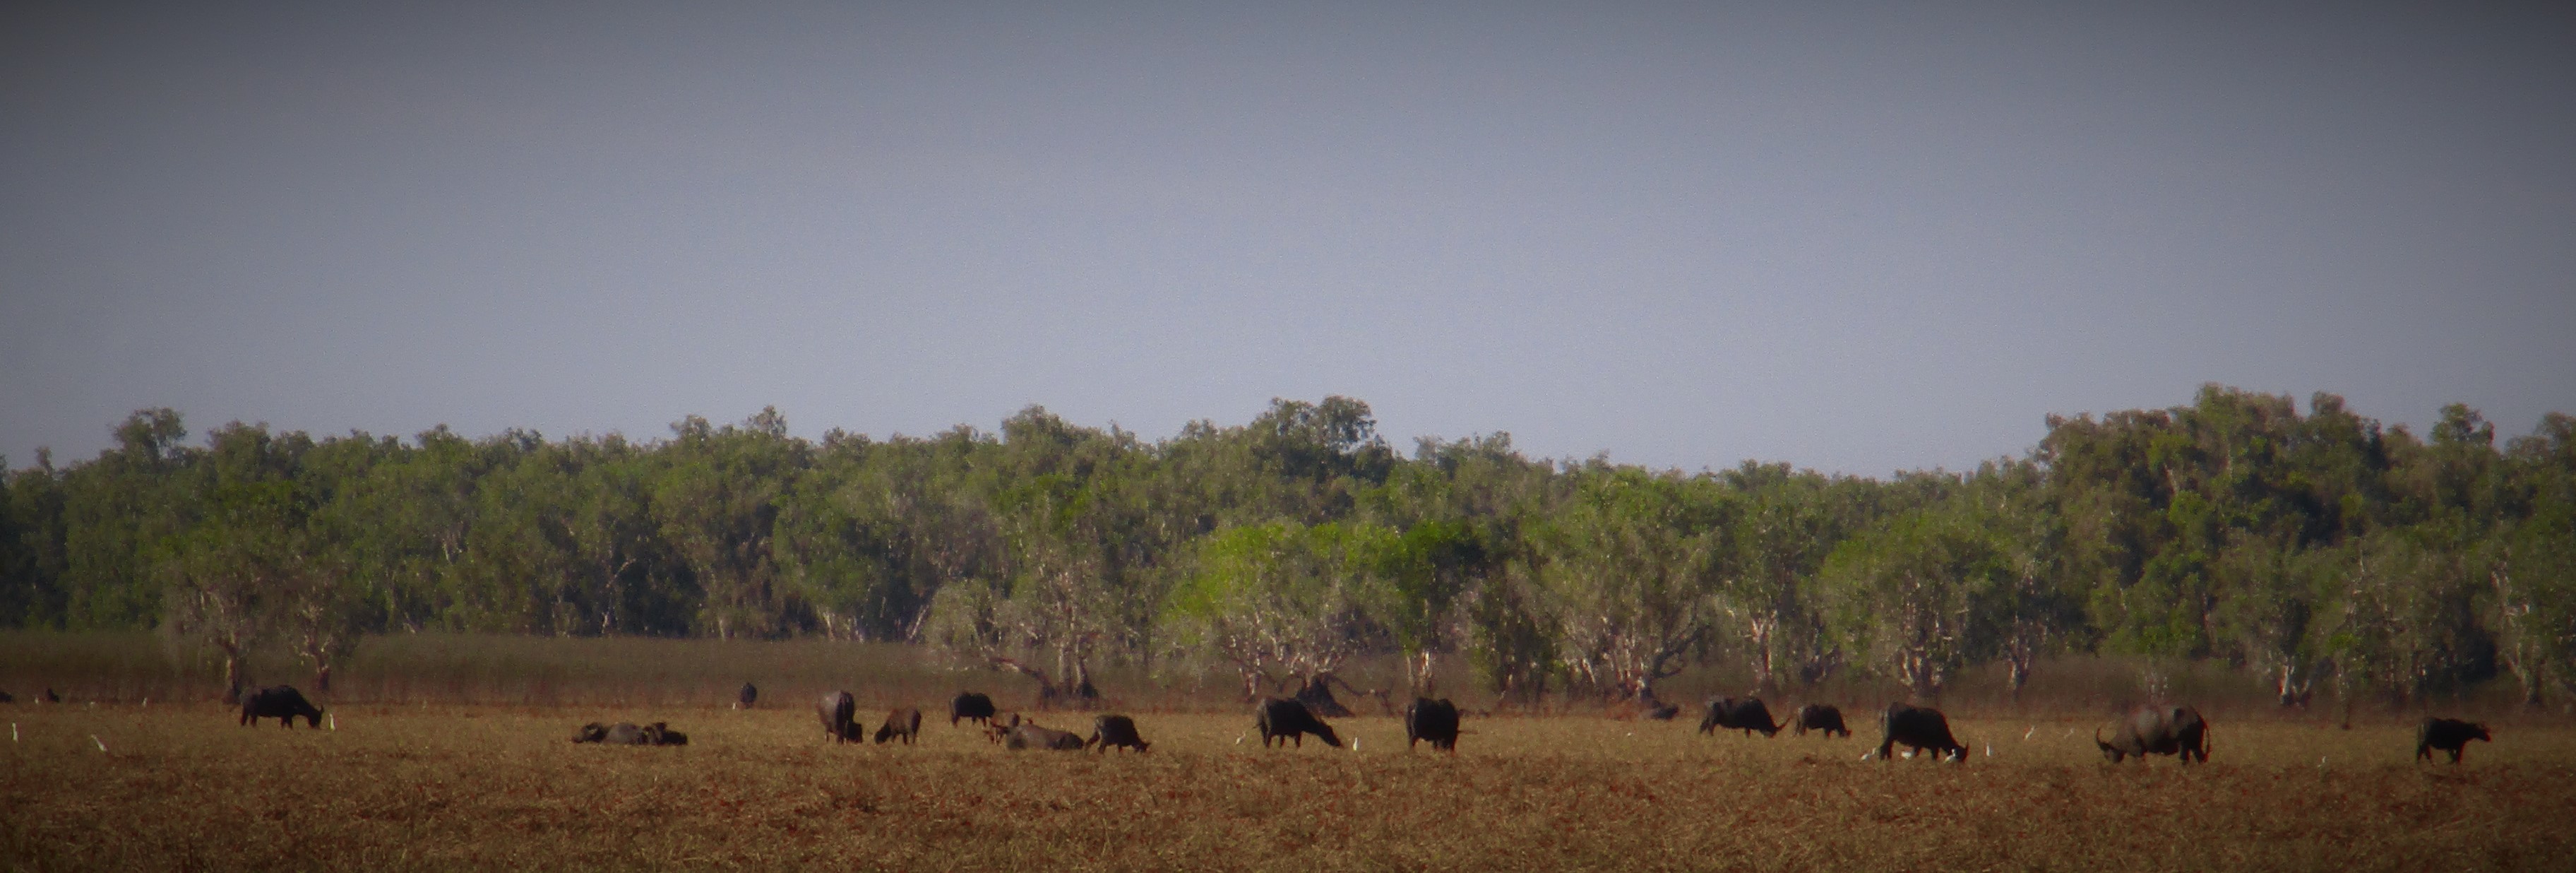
0, 695, 2576, 873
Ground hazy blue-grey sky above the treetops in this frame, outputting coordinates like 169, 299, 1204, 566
0, 3, 2576, 474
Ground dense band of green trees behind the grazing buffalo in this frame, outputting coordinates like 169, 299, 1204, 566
0, 386, 2576, 706
